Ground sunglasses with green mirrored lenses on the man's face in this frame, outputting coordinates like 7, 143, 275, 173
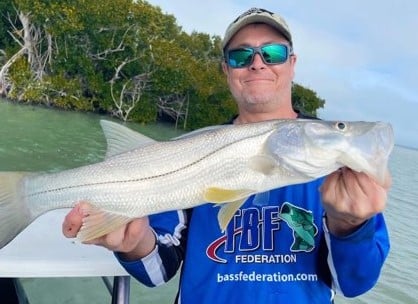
225, 43, 292, 69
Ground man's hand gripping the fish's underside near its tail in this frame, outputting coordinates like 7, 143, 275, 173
62, 202, 156, 260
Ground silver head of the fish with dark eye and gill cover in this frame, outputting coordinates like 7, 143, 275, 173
267, 120, 394, 181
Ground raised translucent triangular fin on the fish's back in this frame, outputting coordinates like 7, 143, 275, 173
100, 120, 155, 158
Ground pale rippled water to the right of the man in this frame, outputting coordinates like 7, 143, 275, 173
336, 147, 418, 304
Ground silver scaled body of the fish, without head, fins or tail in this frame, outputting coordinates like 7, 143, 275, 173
22, 121, 277, 217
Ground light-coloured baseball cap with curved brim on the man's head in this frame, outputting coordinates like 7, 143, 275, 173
222, 7, 292, 50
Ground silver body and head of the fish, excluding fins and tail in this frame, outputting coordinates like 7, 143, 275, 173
20, 120, 393, 221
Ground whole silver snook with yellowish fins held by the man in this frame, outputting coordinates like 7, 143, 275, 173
0, 119, 394, 248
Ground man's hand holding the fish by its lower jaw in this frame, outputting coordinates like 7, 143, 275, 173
320, 168, 392, 236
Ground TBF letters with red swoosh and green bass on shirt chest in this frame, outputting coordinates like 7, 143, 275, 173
206, 202, 318, 263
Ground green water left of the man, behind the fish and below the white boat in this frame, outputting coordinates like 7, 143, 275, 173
0, 99, 181, 304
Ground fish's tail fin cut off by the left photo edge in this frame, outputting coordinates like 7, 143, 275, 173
0, 172, 33, 249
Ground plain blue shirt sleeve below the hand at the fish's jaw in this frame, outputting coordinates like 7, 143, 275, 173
324, 213, 390, 297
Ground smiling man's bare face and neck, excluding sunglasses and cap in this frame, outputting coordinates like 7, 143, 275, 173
223, 24, 296, 113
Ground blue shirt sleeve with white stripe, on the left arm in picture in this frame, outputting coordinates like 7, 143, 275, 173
115, 210, 191, 287
